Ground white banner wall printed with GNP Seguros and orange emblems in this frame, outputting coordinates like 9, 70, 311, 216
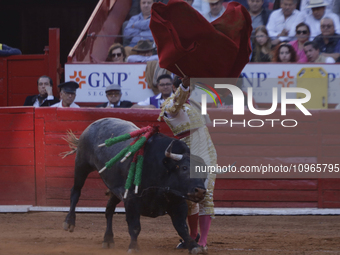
65, 63, 340, 104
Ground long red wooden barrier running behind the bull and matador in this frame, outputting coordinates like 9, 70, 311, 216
0, 107, 340, 208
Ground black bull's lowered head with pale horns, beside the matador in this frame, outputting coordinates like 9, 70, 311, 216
163, 140, 206, 202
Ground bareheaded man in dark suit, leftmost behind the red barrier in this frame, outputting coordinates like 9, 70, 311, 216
24, 75, 59, 107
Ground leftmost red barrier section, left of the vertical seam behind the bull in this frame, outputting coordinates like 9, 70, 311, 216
0, 107, 35, 205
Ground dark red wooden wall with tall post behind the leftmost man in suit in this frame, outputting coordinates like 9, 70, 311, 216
0, 28, 60, 106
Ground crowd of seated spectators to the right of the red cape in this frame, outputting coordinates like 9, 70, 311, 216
248, 0, 340, 63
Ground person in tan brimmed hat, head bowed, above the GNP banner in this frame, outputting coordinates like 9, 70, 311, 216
127, 40, 158, 63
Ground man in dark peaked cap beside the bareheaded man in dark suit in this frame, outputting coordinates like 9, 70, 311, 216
51, 81, 79, 108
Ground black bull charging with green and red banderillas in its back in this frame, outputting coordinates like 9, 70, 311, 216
63, 118, 205, 253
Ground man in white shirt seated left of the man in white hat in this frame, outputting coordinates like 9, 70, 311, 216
266, 0, 303, 45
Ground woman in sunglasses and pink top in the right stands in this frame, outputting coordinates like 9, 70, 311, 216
290, 22, 310, 63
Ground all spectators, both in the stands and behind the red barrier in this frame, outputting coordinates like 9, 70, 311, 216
18, 0, 340, 108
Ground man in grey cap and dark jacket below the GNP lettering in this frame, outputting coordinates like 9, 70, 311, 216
96, 84, 133, 108
